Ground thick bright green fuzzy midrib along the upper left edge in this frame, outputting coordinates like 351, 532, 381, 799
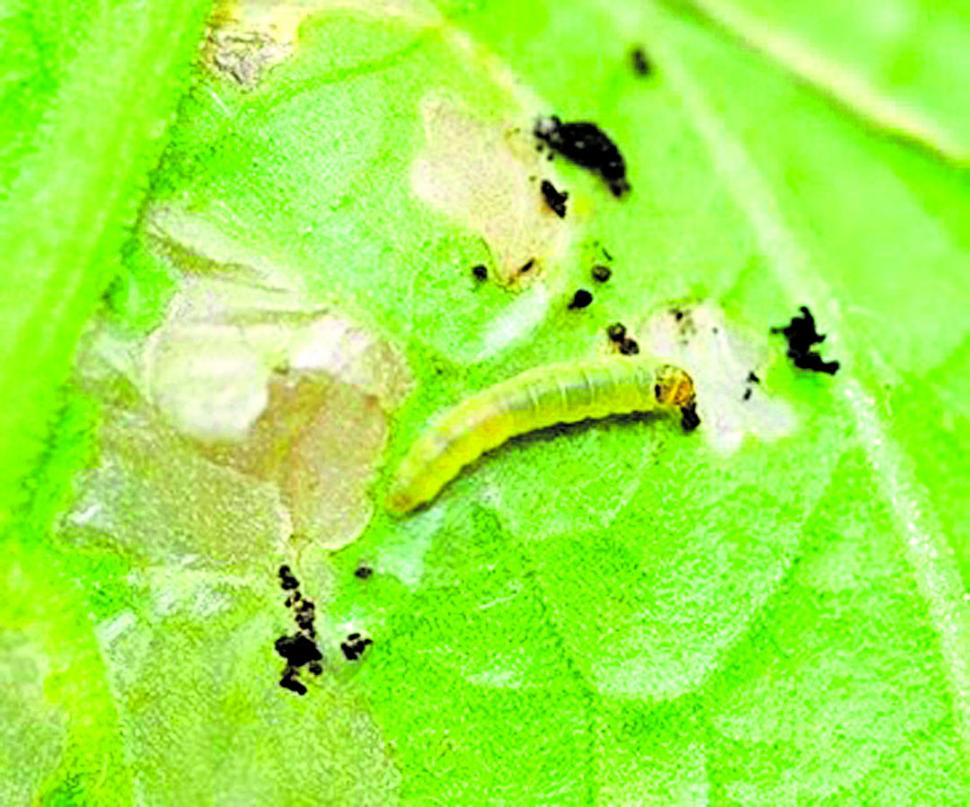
0, 0, 209, 524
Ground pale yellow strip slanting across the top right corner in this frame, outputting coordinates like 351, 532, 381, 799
665, 0, 970, 165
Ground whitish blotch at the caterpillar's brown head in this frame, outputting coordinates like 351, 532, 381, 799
637, 303, 796, 453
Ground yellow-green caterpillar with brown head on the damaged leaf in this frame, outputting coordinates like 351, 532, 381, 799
387, 357, 700, 514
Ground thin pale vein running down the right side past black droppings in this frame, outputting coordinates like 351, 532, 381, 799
651, 0, 970, 751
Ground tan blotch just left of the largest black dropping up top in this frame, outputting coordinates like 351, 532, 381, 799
411, 95, 570, 286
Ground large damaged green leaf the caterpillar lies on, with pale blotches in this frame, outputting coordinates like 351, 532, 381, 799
0, 0, 970, 804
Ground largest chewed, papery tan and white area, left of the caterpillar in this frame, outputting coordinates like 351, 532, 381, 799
65, 211, 409, 563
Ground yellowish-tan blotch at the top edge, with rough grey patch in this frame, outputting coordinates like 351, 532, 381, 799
203, 0, 439, 89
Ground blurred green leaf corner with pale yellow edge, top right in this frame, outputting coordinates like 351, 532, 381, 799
672, 0, 970, 166
